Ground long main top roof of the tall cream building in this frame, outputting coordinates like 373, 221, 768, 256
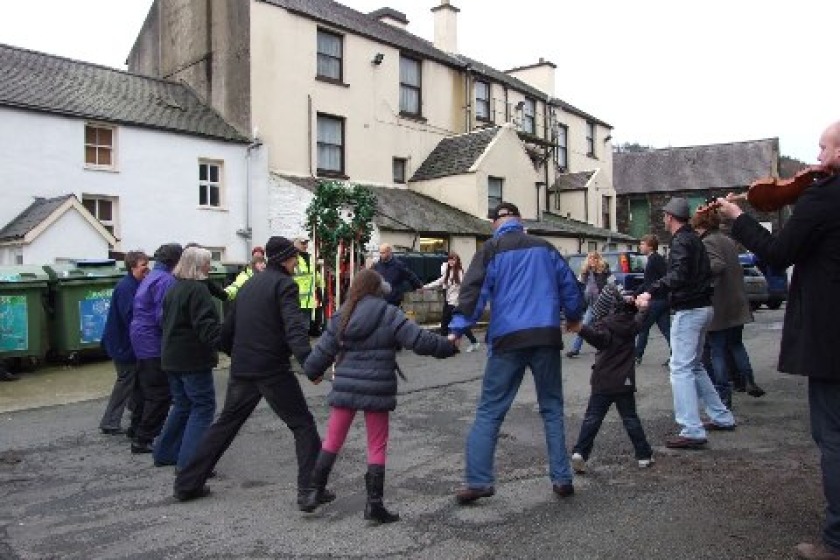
260, 0, 612, 121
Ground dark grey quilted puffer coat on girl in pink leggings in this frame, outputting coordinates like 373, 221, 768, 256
303, 296, 457, 411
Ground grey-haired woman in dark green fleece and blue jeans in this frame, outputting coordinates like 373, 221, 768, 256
153, 247, 221, 469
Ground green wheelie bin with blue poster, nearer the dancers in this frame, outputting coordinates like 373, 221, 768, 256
44, 259, 125, 362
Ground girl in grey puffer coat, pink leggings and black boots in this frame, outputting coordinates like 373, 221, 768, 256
300, 270, 457, 523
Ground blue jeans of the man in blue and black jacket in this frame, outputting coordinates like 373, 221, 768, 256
466, 346, 572, 488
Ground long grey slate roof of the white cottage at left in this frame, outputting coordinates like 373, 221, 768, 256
0, 44, 249, 143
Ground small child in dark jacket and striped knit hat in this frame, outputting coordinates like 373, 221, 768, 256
572, 284, 654, 473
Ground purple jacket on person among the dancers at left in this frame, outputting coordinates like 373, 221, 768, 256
129, 262, 176, 360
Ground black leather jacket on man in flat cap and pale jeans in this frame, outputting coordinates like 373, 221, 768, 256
650, 224, 712, 311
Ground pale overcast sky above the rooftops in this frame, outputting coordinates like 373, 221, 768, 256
0, 0, 840, 163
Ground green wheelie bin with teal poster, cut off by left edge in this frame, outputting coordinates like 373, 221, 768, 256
0, 265, 49, 367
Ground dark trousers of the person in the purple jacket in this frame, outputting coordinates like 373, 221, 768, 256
131, 358, 172, 444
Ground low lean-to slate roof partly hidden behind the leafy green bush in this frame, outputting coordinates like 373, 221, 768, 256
276, 174, 493, 237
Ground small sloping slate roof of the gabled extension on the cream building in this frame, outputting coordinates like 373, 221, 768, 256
409, 126, 500, 181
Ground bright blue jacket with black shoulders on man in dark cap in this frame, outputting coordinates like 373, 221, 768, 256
449, 220, 585, 351
